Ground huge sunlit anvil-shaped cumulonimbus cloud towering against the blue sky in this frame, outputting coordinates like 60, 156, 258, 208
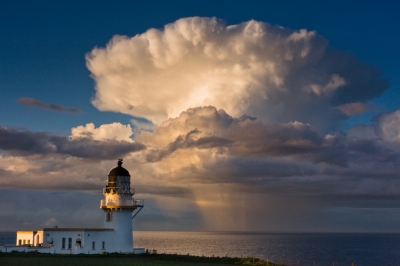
86, 17, 389, 131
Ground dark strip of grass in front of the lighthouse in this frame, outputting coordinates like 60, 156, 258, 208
0, 252, 282, 266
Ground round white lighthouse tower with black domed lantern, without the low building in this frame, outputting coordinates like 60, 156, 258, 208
100, 159, 143, 252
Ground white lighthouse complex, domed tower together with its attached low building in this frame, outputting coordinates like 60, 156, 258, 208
0, 159, 144, 254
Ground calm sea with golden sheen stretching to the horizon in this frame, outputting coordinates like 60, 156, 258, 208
0, 231, 400, 266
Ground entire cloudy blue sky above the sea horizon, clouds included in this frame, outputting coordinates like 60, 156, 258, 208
0, 0, 400, 232
